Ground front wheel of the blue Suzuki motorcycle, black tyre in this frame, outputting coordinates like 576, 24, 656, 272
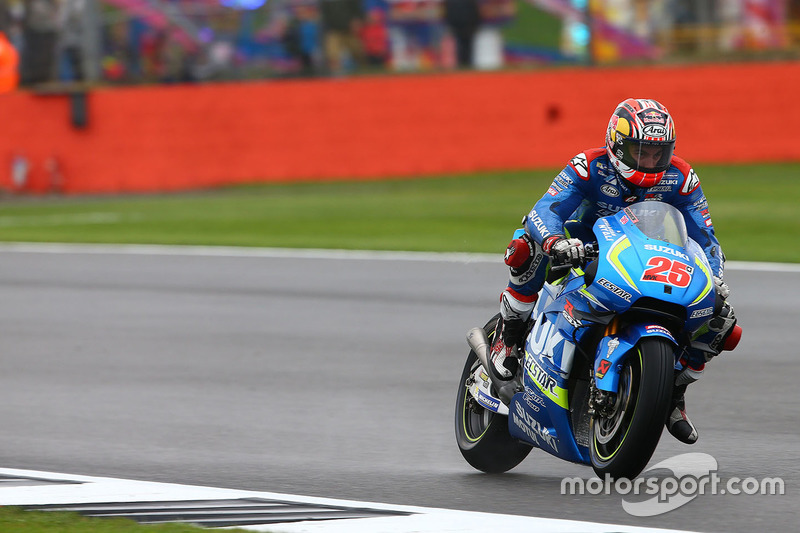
590, 337, 675, 479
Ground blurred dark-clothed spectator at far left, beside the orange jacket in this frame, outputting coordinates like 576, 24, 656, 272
21, 0, 59, 85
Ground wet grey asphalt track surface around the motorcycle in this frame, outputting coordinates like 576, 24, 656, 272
0, 246, 800, 533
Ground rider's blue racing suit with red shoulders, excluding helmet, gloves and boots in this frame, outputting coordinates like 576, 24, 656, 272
501, 148, 725, 365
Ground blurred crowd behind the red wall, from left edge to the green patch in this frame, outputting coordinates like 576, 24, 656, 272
0, 0, 515, 84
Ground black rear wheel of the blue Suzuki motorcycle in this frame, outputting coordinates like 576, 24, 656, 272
455, 314, 532, 474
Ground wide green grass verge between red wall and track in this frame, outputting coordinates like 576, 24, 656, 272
0, 164, 800, 262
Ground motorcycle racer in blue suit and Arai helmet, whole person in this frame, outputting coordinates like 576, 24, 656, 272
490, 98, 741, 444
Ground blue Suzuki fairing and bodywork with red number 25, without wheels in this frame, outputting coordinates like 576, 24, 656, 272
508, 202, 716, 464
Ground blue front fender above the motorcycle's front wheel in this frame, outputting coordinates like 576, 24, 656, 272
594, 324, 678, 393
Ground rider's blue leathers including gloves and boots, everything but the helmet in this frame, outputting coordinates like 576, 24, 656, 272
490, 148, 741, 444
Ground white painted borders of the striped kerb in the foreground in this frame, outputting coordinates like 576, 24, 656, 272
0, 468, 685, 533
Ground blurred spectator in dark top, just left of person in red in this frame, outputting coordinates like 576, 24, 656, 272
319, 0, 364, 74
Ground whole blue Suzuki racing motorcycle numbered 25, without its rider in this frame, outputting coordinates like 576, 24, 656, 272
455, 201, 723, 479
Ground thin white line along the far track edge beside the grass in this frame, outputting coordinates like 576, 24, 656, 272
0, 242, 800, 272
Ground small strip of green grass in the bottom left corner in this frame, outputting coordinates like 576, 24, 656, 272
0, 507, 253, 533
